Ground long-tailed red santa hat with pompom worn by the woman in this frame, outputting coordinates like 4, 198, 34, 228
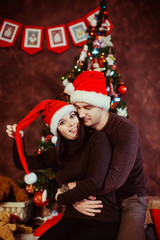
15, 99, 76, 184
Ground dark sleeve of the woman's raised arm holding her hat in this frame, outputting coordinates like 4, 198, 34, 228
13, 139, 57, 170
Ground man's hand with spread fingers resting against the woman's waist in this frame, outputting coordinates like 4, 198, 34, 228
73, 196, 103, 217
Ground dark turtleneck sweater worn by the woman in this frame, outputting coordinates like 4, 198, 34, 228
13, 128, 119, 222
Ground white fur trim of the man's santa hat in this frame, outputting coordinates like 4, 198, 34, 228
70, 90, 111, 110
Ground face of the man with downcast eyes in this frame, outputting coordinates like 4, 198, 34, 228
74, 102, 103, 129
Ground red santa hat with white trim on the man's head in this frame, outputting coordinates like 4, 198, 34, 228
64, 71, 110, 110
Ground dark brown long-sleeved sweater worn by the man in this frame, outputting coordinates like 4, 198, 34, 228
102, 113, 146, 200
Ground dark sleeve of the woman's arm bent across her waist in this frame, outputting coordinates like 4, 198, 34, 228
57, 132, 112, 205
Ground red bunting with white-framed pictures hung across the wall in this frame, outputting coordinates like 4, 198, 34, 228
0, 7, 112, 55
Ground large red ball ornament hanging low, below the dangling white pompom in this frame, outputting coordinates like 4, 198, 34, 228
33, 190, 49, 207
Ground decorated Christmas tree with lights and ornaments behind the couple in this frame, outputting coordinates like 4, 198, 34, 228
26, 1, 128, 210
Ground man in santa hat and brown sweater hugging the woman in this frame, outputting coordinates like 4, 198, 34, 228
65, 71, 146, 240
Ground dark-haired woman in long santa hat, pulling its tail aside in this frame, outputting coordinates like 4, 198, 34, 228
6, 100, 119, 240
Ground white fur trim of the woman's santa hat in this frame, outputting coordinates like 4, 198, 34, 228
50, 104, 77, 136
